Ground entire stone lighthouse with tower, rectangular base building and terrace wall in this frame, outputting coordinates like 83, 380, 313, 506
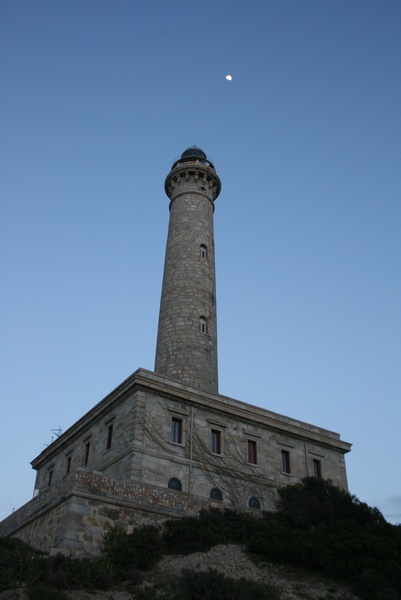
0, 147, 350, 555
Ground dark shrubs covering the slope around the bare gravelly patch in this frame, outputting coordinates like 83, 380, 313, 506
0, 478, 401, 600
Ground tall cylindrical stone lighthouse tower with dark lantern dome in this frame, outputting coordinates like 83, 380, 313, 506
155, 147, 221, 394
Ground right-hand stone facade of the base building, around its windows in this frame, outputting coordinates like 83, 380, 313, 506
141, 392, 347, 510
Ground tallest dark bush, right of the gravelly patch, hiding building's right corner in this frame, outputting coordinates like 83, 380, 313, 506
248, 478, 401, 600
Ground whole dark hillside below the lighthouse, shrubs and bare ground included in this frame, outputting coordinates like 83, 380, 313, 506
0, 478, 401, 600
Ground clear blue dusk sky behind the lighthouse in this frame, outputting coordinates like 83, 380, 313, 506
0, 0, 401, 522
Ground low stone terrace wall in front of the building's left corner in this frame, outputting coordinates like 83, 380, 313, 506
0, 470, 216, 556
